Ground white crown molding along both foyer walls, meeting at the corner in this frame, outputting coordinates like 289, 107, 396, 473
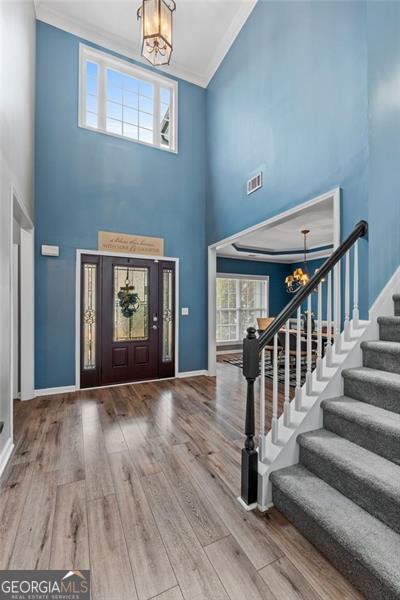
34, 0, 257, 88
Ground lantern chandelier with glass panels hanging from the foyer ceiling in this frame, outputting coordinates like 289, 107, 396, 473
137, 0, 176, 66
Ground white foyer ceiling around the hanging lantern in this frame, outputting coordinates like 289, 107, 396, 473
35, 0, 257, 87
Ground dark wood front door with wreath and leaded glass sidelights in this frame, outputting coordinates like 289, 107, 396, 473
81, 255, 175, 387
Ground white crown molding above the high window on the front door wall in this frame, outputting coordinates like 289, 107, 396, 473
35, 0, 208, 88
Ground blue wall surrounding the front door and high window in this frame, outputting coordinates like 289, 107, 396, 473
36, 22, 207, 388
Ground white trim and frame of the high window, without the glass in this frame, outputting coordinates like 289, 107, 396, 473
78, 44, 178, 154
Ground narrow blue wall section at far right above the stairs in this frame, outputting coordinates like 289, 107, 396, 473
367, 2, 400, 303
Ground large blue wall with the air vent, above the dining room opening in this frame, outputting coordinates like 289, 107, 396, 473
207, 1, 369, 314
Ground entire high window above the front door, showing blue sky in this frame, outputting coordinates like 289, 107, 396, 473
79, 44, 177, 152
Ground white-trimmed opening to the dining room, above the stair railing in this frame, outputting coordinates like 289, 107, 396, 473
208, 188, 340, 375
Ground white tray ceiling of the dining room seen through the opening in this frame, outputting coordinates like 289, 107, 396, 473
217, 199, 334, 263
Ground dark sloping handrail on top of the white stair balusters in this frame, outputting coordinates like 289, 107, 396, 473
258, 221, 368, 352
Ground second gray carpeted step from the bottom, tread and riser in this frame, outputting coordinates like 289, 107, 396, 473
297, 429, 400, 533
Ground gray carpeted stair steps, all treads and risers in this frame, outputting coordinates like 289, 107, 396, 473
270, 295, 400, 600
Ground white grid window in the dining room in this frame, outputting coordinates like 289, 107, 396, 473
217, 275, 268, 343
